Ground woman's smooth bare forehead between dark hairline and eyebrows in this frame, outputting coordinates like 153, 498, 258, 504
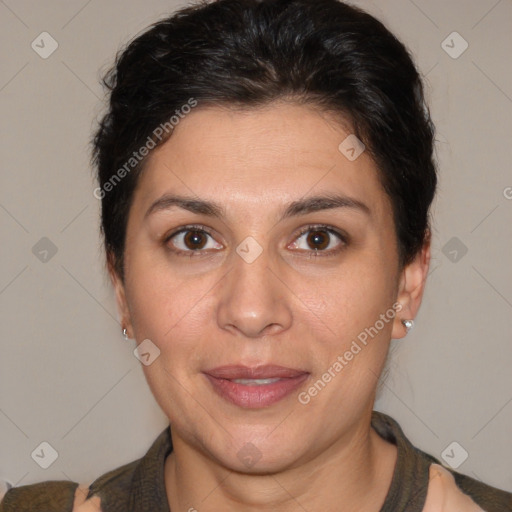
130, 103, 390, 222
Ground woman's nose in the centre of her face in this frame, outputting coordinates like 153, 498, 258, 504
217, 241, 292, 338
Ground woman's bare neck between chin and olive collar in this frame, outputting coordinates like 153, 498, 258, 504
165, 411, 397, 512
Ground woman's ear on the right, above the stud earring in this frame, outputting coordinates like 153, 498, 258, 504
391, 230, 431, 339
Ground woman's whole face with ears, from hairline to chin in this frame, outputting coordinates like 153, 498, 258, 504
113, 104, 429, 472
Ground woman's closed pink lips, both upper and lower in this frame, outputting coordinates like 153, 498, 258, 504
204, 365, 309, 409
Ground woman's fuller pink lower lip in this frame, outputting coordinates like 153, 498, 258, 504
205, 373, 309, 409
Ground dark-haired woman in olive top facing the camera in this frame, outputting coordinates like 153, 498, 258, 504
0, 0, 512, 512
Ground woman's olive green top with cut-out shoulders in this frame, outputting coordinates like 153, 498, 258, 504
0, 411, 512, 512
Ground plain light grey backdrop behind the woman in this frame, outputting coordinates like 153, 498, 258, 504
0, 0, 512, 491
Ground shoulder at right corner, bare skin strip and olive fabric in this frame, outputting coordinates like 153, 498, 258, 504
423, 463, 512, 512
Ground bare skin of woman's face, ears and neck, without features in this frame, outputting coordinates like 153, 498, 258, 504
110, 102, 430, 512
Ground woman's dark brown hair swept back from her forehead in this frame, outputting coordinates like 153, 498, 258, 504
93, 0, 437, 279
